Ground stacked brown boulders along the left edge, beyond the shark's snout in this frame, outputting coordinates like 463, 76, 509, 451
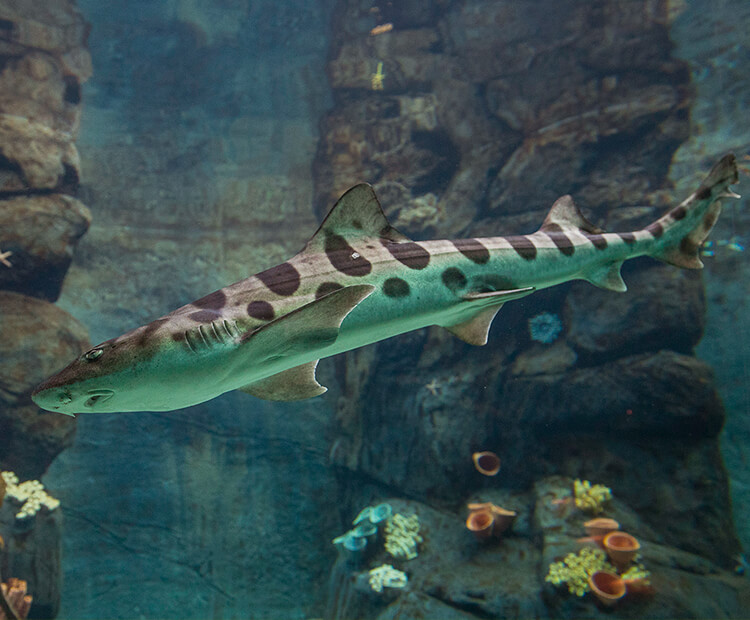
0, 0, 91, 618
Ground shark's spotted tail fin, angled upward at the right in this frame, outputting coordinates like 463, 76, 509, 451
646, 153, 739, 269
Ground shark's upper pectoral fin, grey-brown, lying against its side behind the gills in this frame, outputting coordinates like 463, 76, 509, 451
241, 284, 375, 356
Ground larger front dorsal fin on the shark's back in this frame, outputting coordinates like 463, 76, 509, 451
303, 183, 410, 252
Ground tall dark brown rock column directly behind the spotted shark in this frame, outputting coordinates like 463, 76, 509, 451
314, 0, 738, 617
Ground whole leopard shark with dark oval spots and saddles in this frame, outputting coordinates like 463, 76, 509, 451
31, 154, 739, 415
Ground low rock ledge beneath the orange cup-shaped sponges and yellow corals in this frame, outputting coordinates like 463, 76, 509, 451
328, 486, 750, 620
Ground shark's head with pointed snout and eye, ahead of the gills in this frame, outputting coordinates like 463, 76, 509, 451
31, 325, 191, 415
